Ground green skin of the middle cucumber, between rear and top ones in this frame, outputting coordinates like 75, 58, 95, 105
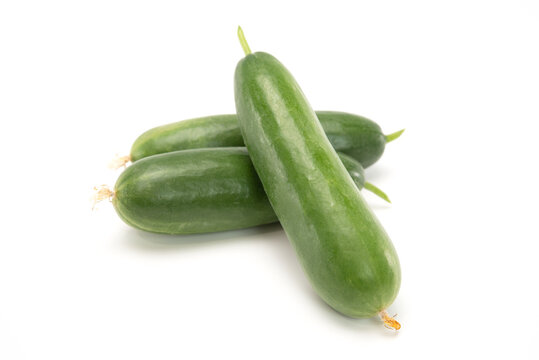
112, 147, 365, 234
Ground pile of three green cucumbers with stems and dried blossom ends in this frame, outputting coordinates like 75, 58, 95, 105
96, 28, 402, 330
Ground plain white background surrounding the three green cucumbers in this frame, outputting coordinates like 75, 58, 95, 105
0, 0, 539, 360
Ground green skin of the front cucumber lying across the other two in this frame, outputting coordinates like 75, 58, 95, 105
234, 53, 401, 317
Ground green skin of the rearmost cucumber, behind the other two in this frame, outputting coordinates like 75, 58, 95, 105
131, 111, 386, 168
